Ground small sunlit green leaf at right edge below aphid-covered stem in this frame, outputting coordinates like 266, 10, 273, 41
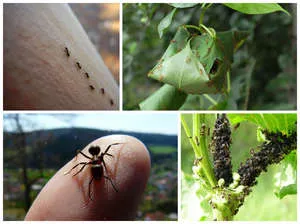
274, 151, 297, 199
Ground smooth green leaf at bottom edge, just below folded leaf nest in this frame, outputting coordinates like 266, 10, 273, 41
139, 84, 187, 110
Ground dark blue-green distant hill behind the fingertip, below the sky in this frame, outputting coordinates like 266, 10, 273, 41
3, 128, 177, 168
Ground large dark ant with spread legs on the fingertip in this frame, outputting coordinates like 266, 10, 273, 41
64, 143, 122, 200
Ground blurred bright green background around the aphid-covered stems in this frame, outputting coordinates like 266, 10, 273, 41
181, 114, 297, 221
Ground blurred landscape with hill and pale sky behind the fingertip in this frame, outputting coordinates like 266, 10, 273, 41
3, 112, 178, 221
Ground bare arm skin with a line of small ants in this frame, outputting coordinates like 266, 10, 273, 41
3, 4, 119, 110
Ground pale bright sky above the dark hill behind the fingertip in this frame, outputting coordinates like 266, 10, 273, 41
4, 111, 178, 135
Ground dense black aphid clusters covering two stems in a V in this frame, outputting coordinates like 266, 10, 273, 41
210, 114, 297, 190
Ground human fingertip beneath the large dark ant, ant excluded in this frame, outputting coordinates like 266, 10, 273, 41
25, 135, 151, 221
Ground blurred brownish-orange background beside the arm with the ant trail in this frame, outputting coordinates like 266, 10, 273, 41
69, 3, 120, 82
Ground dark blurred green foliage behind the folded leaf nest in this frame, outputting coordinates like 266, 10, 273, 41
123, 4, 297, 110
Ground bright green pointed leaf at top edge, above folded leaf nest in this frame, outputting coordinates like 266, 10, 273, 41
223, 3, 289, 15
